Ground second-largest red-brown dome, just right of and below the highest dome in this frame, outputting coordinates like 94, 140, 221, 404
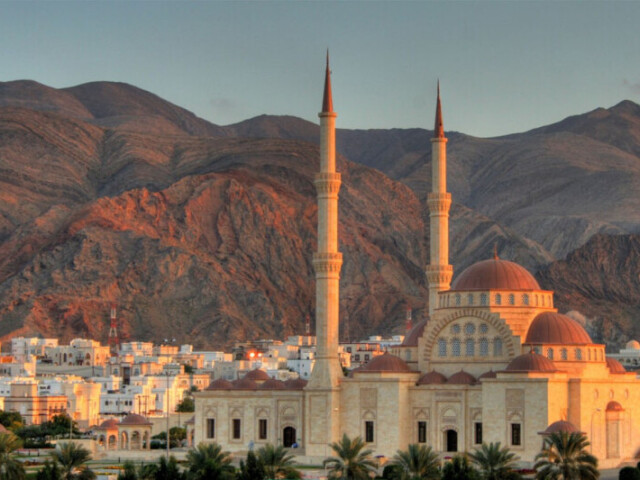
524, 312, 593, 345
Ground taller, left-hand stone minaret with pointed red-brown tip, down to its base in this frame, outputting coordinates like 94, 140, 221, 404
304, 52, 343, 458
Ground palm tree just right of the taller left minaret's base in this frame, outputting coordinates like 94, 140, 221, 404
323, 433, 376, 480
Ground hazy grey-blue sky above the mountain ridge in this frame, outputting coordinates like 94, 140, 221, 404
0, 0, 640, 137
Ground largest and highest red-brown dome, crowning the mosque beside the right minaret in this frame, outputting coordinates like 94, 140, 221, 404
451, 258, 540, 290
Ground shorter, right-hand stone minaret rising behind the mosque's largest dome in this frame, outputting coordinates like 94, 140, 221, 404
427, 81, 453, 315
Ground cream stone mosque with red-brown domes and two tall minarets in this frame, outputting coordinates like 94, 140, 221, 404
193, 59, 640, 468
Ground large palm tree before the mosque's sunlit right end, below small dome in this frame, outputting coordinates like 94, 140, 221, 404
533, 432, 600, 480
